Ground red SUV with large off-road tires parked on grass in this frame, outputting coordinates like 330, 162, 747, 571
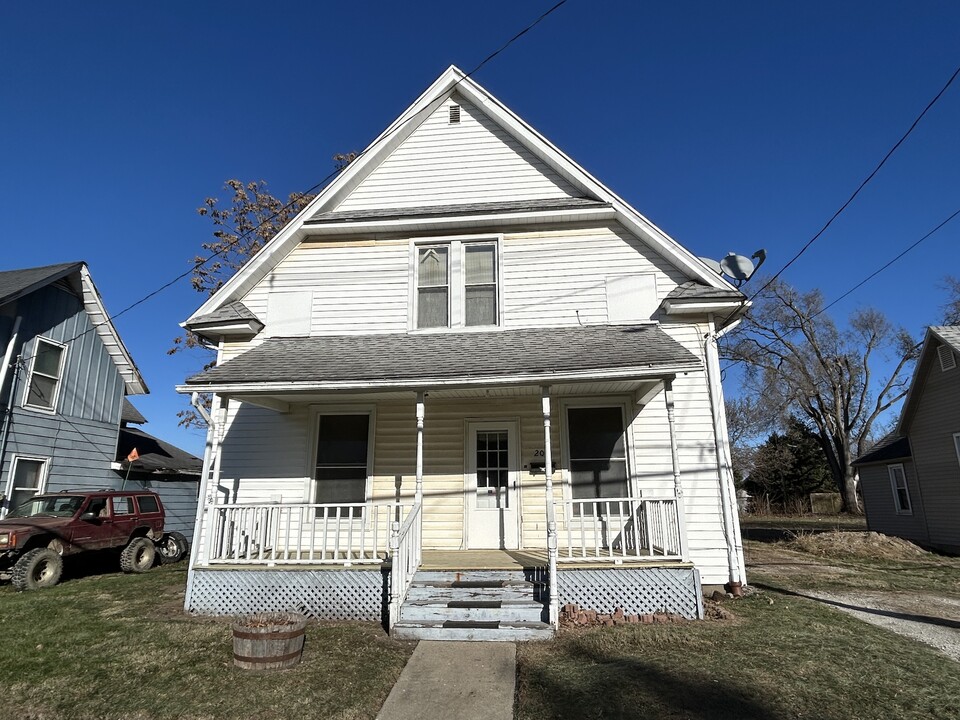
0, 490, 185, 590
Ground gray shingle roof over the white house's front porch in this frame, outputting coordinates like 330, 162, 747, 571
187, 325, 700, 385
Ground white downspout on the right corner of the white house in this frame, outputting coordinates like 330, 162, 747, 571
703, 313, 746, 596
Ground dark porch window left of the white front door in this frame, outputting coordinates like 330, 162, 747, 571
314, 415, 370, 516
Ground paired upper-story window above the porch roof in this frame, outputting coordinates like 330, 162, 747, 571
414, 239, 500, 329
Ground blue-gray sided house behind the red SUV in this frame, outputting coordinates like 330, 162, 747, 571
0, 262, 147, 514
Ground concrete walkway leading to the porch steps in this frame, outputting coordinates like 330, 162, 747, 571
377, 640, 517, 720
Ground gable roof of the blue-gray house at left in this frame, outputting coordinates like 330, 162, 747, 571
0, 261, 149, 395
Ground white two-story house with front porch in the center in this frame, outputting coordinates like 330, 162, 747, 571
178, 67, 746, 639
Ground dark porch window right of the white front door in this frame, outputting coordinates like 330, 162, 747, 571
567, 405, 629, 515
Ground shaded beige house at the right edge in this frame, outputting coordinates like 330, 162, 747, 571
854, 325, 960, 553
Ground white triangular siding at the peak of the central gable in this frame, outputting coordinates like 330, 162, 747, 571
336, 95, 580, 211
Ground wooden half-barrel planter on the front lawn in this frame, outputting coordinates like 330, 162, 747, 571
233, 613, 307, 670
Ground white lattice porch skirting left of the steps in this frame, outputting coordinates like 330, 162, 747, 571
186, 568, 389, 622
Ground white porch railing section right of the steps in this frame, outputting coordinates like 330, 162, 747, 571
559, 496, 684, 562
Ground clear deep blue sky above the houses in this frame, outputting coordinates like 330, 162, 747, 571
0, 0, 960, 452
